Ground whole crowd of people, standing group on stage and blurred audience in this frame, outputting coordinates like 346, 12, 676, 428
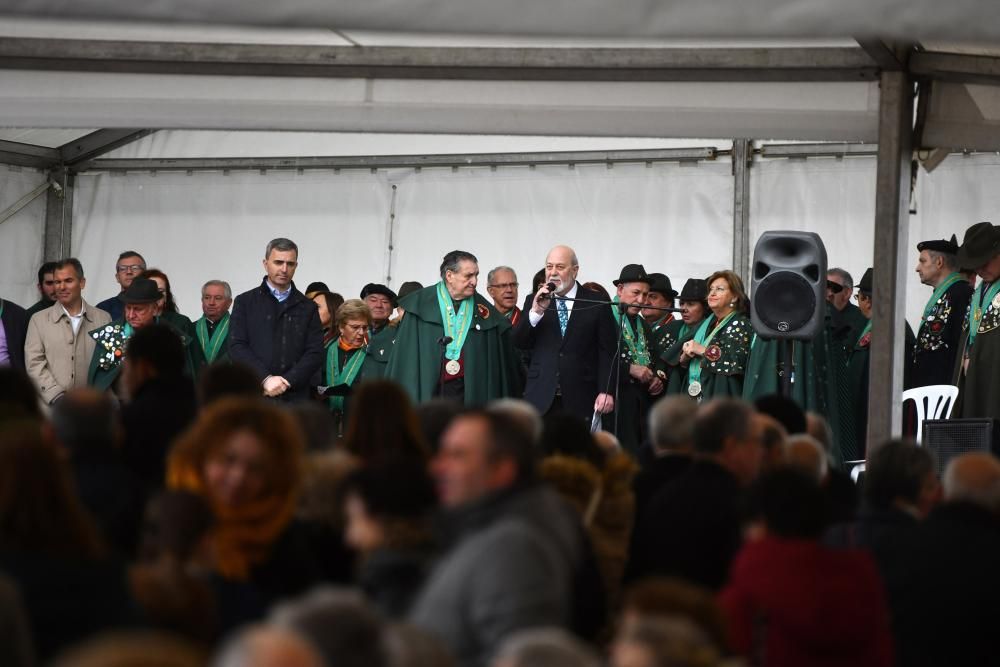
0, 223, 1000, 667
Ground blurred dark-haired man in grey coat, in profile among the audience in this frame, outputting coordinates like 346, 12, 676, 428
410, 411, 584, 667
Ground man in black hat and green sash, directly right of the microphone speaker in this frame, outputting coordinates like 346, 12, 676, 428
605, 264, 664, 456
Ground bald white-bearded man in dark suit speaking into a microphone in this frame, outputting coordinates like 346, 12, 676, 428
513, 246, 616, 420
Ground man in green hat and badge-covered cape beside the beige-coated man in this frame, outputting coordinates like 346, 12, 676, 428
87, 278, 192, 395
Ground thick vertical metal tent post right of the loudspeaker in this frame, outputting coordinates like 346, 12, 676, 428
867, 72, 913, 455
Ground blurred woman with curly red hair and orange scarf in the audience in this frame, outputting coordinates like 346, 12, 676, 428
167, 398, 320, 602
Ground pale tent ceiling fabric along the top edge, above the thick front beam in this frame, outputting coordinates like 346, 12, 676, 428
0, 0, 1000, 40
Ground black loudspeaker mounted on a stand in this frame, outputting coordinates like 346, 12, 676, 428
750, 231, 826, 340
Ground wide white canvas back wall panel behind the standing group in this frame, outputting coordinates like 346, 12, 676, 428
73, 162, 732, 315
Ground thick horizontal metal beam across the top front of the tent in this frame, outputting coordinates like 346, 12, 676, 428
0, 37, 878, 81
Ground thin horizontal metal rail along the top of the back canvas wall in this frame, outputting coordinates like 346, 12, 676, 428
76, 147, 723, 171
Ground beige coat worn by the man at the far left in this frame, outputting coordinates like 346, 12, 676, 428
24, 301, 111, 403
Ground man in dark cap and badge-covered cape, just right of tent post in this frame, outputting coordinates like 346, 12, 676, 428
913, 235, 972, 387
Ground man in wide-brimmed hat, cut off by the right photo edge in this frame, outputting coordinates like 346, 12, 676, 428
954, 222, 1000, 418
